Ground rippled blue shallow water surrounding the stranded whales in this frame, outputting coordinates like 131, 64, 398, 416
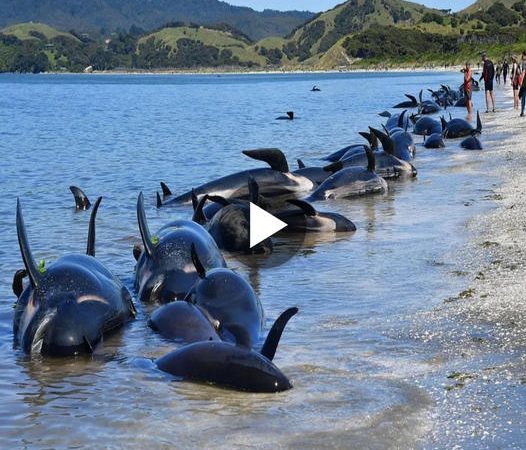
0, 73, 502, 448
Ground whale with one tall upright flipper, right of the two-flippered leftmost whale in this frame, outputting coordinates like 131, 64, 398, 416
135, 192, 226, 303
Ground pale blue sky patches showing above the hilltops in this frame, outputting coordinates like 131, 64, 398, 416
225, 0, 475, 12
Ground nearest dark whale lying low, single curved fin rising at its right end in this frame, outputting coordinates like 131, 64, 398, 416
155, 308, 298, 393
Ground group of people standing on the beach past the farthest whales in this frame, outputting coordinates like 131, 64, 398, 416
462, 51, 526, 117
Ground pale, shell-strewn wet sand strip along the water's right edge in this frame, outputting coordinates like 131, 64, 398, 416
416, 86, 526, 448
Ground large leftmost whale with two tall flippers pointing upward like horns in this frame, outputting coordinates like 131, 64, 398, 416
13, 197, 135, 356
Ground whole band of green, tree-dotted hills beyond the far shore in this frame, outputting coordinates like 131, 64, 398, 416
0, 0, 526, 71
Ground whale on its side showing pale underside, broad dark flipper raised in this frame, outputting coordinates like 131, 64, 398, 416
158, 148, 314, 206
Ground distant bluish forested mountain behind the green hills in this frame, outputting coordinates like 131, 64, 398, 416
0, 0, 313, 39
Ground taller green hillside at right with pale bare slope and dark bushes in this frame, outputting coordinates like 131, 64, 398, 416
276, 0, 526, 69
